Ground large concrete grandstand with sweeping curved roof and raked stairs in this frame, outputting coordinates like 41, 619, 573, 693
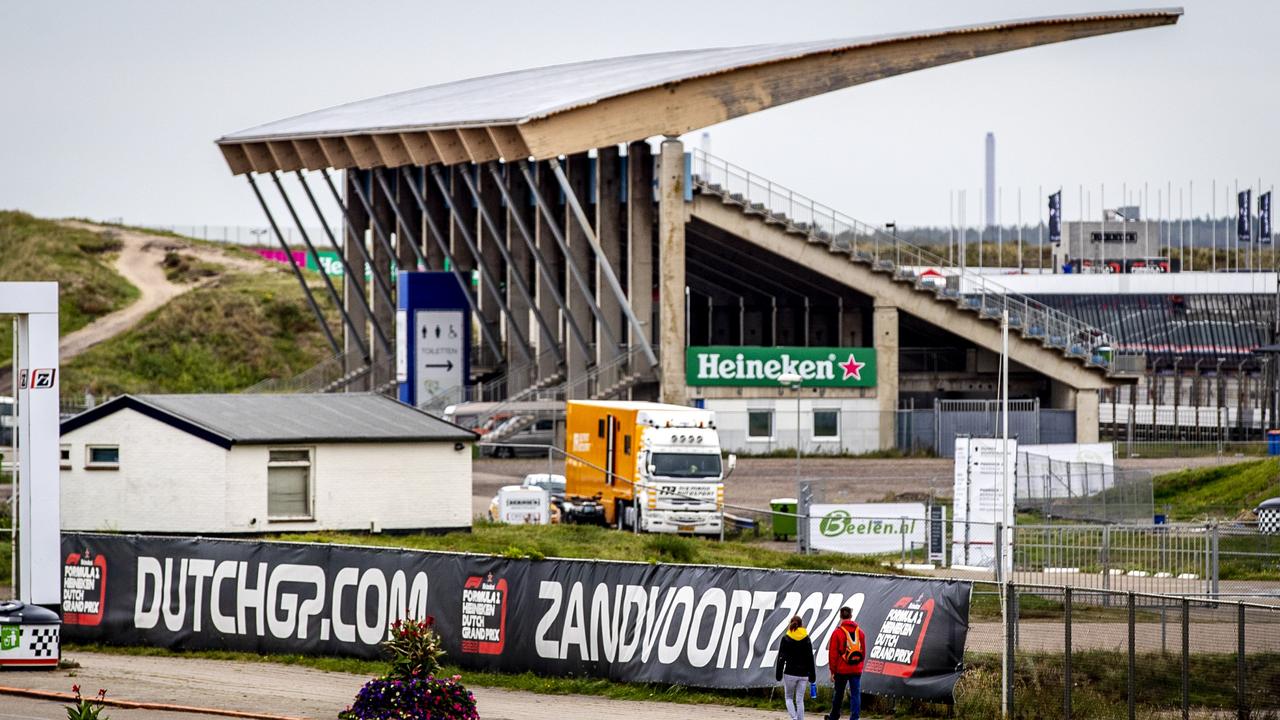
218, 10, 1180, 452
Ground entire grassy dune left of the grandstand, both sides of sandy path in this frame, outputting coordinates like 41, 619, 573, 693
0, 211, 338, 400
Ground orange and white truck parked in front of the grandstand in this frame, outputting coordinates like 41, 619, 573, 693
564, 400, 736, 536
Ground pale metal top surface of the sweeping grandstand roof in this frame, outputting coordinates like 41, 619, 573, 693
219, 8, 1181, 143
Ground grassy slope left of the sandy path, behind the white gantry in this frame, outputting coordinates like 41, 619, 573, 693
0, 210, 138, 365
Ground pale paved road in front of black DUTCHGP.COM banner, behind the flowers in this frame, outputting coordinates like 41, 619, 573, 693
0, 652, 783, 720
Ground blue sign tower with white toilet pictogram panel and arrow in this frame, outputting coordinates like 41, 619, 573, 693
396, 272, 471, 405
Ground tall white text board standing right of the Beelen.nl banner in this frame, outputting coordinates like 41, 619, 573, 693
951, 437, 1018, 571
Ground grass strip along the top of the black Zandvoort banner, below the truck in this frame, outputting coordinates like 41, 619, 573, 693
270, 523, 892, 573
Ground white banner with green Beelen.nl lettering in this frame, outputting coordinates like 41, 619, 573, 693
809, 502, 925, 555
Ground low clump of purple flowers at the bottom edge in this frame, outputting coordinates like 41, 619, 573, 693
338, 675, 480, 720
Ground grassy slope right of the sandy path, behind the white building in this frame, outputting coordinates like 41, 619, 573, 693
63, 270, 335, 396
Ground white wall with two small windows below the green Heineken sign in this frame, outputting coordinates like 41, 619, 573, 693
704, 396, 879, 455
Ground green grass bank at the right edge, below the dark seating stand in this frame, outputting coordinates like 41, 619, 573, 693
1155, 459, 1280, 520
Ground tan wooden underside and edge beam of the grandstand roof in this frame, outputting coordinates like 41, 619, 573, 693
212, 10, 1181, 174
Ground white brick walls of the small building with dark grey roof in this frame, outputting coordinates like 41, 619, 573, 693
61, 410, 471, 534
